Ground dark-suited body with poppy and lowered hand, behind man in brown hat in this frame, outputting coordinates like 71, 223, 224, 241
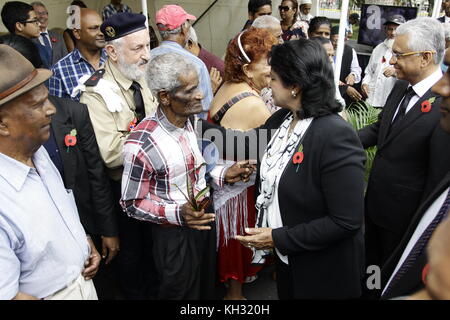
44, 96, 119, 299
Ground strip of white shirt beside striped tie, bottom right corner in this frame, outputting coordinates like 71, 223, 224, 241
383, 188, 450, 294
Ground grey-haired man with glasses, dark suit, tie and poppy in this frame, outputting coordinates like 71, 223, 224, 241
358, 18, 450, 276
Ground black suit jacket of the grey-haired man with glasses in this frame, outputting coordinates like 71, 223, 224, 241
358, 80, 450, 237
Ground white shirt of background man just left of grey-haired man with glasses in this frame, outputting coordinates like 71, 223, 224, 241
362, 39, 397, 108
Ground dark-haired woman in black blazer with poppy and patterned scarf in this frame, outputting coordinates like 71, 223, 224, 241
237, 39, 365, 299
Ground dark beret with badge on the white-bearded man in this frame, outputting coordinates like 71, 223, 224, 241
100, 12, 147, 41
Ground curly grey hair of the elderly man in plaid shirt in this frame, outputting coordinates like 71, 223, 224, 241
146, 52, 198, 97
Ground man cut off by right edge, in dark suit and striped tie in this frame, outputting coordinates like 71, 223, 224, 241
381, 46, 450, 299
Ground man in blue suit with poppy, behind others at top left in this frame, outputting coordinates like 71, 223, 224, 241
31, 1, 67, 67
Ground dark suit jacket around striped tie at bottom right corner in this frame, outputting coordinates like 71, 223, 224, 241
381, 172, 450, 299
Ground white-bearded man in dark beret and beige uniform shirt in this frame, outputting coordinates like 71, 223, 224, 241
78, 12, 157, 299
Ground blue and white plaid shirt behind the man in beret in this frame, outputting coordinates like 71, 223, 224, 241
48, 48, 107, 101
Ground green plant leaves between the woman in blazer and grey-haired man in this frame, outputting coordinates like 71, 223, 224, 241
346, 100, 380, 181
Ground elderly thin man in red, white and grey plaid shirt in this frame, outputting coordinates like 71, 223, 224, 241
121, 53, 252, 299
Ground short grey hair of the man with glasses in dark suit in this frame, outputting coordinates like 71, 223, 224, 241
395, 17, 445, 64
